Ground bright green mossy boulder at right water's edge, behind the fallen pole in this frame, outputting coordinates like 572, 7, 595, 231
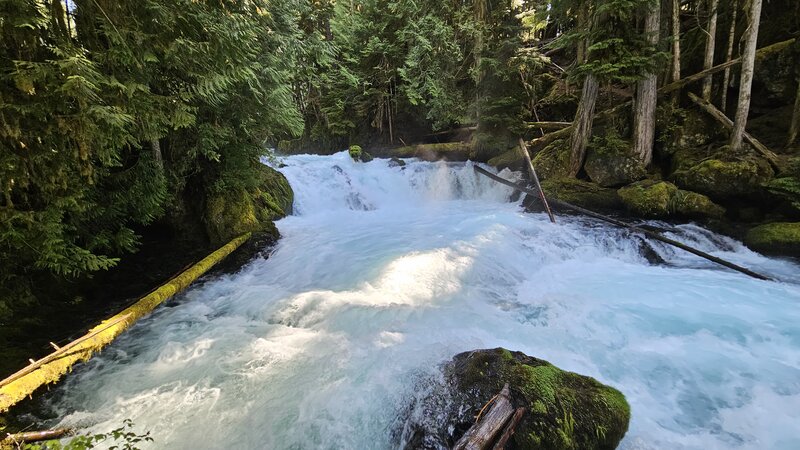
618, 180, 725, 219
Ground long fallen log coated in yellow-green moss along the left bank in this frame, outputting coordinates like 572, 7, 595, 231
0, 233, 250, 413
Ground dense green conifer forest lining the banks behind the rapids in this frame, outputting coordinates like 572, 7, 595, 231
0, 0, 800, 362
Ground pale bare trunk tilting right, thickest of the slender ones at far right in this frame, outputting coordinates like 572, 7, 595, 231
730, 0, 762, 151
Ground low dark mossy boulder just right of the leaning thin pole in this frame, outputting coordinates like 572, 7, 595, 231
525, 178, 623, 211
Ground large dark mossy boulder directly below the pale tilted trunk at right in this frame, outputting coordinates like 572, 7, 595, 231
672, 149, 774, 199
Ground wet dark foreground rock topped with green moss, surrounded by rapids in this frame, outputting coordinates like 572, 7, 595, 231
401, 348, 630, 450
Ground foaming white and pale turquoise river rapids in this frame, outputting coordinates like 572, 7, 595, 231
37, 153, 800, 449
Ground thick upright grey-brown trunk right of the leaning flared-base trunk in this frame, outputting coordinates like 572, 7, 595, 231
633, 4, 661, 166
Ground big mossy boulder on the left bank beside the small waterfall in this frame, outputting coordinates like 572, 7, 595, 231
204, 165, 294, 245
